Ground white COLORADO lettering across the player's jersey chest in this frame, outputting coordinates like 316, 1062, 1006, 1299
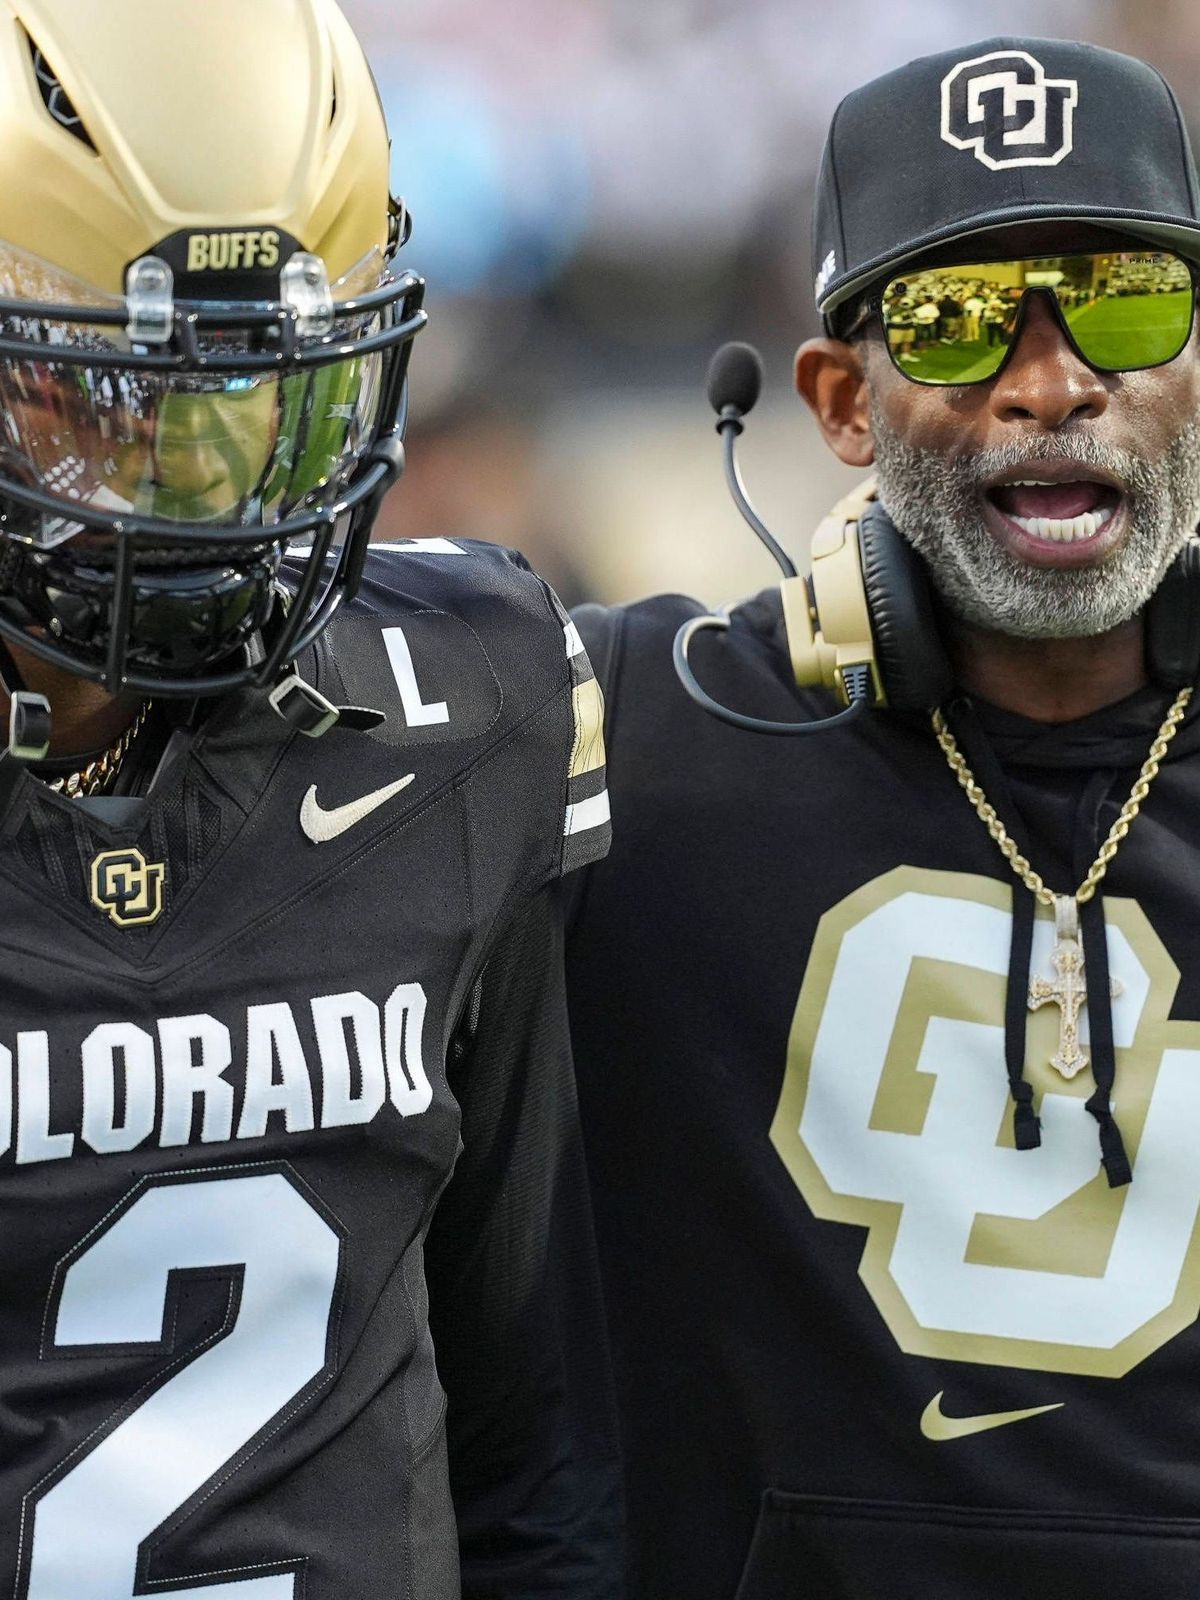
0, 984, 434, 1165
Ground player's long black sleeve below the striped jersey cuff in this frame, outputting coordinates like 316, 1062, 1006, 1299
427, 886, 624, 1600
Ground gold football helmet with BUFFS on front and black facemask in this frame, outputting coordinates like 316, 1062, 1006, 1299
0, 0, 424, 696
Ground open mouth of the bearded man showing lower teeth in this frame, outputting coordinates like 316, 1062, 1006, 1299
984, 462, 1126, 565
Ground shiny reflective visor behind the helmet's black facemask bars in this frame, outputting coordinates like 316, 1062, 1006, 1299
0, 334, 382, 547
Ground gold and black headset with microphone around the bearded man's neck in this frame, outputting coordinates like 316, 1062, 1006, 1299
674, 344, 1200, 734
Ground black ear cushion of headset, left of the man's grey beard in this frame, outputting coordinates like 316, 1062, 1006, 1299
858, 501, 954, 710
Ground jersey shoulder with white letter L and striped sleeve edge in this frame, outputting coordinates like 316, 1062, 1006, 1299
322, 539, 610, 872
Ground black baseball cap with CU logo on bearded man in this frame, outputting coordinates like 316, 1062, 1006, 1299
813, 38, 1200, 326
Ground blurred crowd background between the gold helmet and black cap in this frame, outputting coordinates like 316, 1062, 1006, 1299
344, 0, 1200, 603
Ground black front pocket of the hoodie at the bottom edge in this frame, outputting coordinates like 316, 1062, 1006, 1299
736, 1490, 1200, 1600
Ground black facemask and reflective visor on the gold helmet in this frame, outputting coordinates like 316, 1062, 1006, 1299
0, 233, 426, 696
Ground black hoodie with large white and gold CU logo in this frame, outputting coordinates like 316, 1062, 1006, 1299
568, 595, 1200, 1600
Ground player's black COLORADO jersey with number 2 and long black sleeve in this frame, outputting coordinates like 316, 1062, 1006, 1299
0, 541, 616, 1600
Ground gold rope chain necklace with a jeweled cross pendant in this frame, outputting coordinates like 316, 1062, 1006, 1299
931, 683, 1192, 1078
